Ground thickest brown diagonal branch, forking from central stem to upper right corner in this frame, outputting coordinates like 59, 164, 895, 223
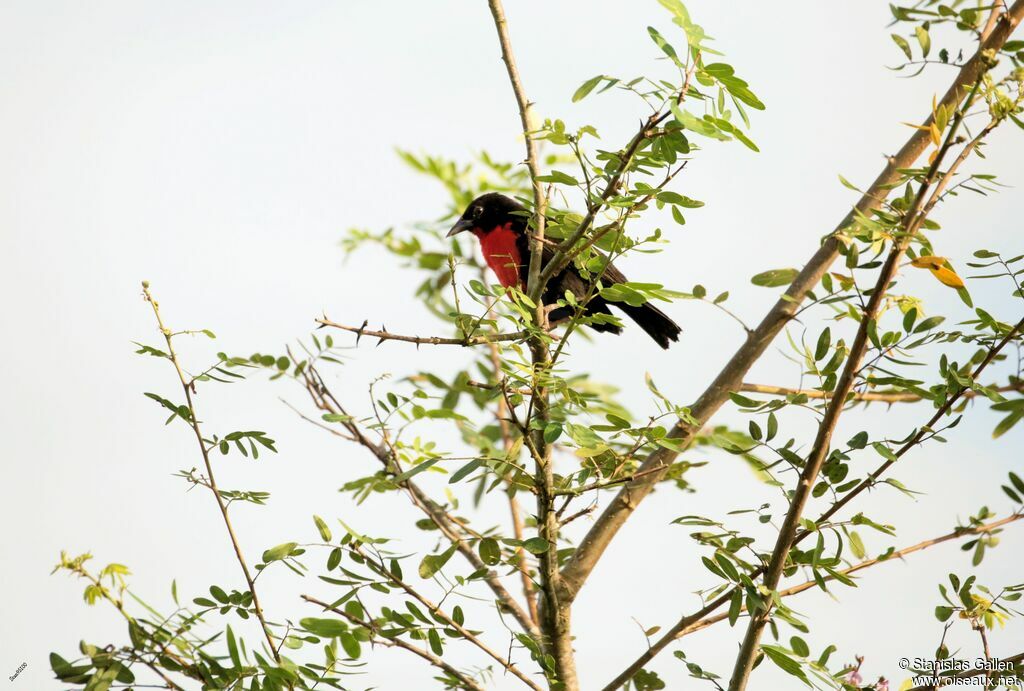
562, 5, 1024, 610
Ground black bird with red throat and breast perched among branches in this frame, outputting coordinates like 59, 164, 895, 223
447, 192, 682, 348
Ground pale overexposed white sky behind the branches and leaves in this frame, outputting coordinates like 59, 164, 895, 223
0, 0, 1024, 691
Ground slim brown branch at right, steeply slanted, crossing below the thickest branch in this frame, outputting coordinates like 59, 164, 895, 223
729, 77, 987, 691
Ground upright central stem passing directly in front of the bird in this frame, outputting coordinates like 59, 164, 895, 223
487, 0, 579, 691
